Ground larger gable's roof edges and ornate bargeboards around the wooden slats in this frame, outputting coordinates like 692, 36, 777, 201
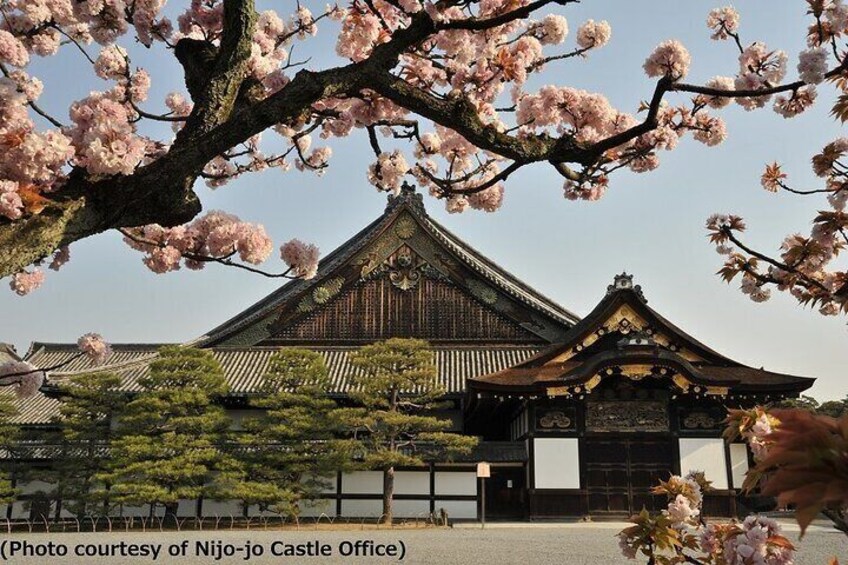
195, 185, 579, 347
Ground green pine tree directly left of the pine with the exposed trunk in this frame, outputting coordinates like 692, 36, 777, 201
241, 349, 352, 515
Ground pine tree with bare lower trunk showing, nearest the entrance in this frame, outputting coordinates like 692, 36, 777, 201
341, 338, 477, 524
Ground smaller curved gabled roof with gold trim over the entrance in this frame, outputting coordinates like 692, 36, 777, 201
468, 273, 815, 395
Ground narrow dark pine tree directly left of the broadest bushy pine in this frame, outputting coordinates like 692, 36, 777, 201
53, 373, 126, 518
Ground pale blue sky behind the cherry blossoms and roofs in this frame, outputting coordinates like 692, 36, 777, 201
0, 0, 848, 400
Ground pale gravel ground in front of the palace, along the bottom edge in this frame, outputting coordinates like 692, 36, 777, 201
0, 523, 848, 565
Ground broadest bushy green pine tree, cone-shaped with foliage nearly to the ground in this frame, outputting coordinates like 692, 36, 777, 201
103, 346, 241, 516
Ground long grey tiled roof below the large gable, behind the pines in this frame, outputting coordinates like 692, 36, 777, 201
27, 343, 539, 404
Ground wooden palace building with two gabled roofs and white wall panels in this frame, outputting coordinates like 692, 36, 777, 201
0, 187, 813, 519
